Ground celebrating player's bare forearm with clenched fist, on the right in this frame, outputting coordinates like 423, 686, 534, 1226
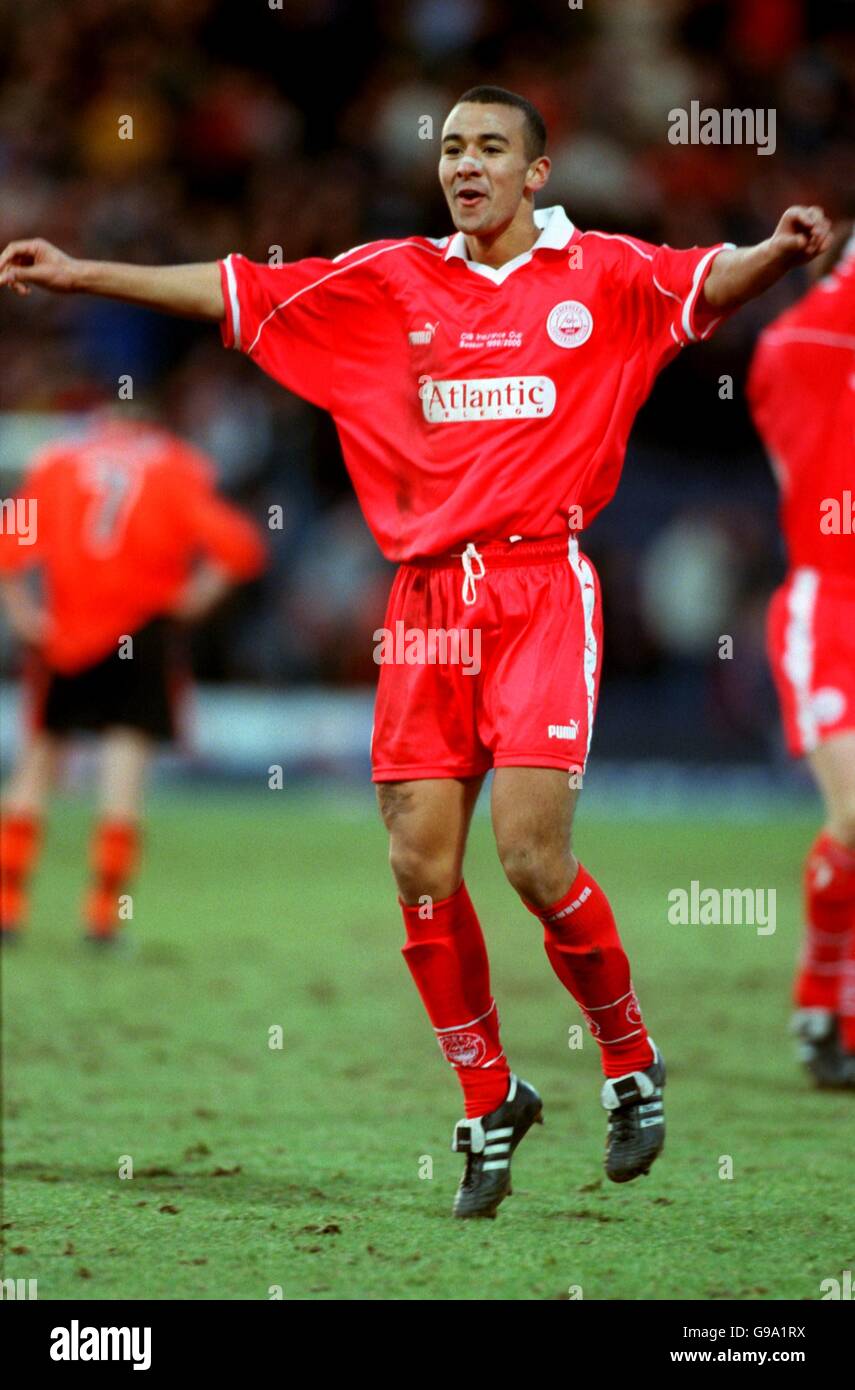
703, 207, 831, 310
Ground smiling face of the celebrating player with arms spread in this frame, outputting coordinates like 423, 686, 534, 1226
439, 101, 548, 236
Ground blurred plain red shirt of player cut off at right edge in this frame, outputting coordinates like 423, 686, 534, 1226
748, 238, 855, 577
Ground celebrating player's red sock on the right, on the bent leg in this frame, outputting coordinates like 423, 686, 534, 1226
523, 865, 653, 1076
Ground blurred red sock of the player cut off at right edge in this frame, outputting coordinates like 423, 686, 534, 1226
795, 830, 855, 1051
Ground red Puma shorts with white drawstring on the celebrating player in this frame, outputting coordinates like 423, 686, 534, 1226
371, 537, 602, 781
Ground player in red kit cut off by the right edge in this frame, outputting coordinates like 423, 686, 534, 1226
748, 227, 855, 1087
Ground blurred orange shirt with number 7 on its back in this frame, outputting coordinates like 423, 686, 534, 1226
0, 421, 264, 673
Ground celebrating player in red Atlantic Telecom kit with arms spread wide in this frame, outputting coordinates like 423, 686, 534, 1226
0, 88, 827, 1218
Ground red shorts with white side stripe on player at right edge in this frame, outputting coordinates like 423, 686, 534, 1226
767, 567, 855, 758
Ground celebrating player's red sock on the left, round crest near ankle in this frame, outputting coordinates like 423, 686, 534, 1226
400, 883, 510, 1119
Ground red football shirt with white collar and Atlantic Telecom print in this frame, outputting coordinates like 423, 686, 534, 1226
220, 207, 722, 560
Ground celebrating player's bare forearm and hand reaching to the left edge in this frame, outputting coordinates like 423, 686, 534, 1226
0, 238, 225, 322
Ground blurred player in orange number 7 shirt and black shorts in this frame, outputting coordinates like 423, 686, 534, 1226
0, 416, 264, 944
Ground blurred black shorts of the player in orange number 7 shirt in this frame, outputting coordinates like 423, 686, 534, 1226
36, 619, 186, 741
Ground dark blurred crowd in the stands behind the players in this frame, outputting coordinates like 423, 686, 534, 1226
0, 0, 855, 756
